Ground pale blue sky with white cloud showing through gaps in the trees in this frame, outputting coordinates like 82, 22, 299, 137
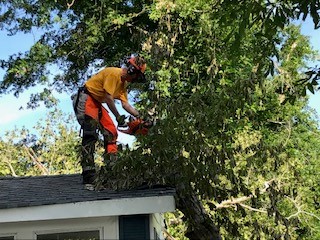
0, 19, 320, 143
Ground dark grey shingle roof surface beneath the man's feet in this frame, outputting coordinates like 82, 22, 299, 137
0, 174, 175, 209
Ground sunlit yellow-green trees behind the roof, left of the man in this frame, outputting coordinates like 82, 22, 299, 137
0, 109, 80, 176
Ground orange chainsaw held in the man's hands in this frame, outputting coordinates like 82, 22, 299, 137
118, 116, 153, 136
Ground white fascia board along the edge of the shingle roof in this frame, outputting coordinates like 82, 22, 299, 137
0, 196, 175, 223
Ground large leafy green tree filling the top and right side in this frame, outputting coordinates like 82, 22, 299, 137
0, 0, 319, 239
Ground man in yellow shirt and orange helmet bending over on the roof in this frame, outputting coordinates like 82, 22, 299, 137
74, 56, 146, 184
